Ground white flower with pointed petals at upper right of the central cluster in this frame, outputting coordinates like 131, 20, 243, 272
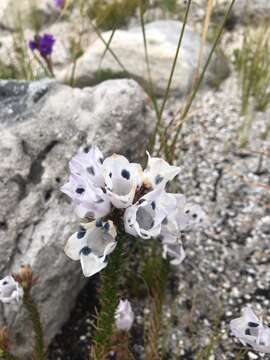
144, 152, 180, 189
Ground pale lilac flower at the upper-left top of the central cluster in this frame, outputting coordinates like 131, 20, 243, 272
69, 145, 104, 187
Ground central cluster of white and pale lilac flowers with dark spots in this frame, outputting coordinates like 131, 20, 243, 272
61, 146, 205, 276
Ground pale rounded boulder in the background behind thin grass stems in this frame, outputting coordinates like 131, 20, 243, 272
57, 20, 229, 95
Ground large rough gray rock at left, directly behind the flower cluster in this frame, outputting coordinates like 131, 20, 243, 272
0, 80, 153, 358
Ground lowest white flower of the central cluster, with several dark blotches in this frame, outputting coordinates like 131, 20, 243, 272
65, 219, 116, 277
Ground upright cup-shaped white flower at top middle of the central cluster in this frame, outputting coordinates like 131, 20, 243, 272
103, 154, 142, 209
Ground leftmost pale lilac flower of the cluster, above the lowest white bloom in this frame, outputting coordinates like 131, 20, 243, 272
61, 174, 111, 219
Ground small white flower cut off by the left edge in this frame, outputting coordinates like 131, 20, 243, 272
0, 275, 23, 303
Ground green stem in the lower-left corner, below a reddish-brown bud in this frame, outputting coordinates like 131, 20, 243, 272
23, 289, 46, 360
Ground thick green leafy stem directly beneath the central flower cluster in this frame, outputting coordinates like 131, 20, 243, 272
90, 231, 127, 360
